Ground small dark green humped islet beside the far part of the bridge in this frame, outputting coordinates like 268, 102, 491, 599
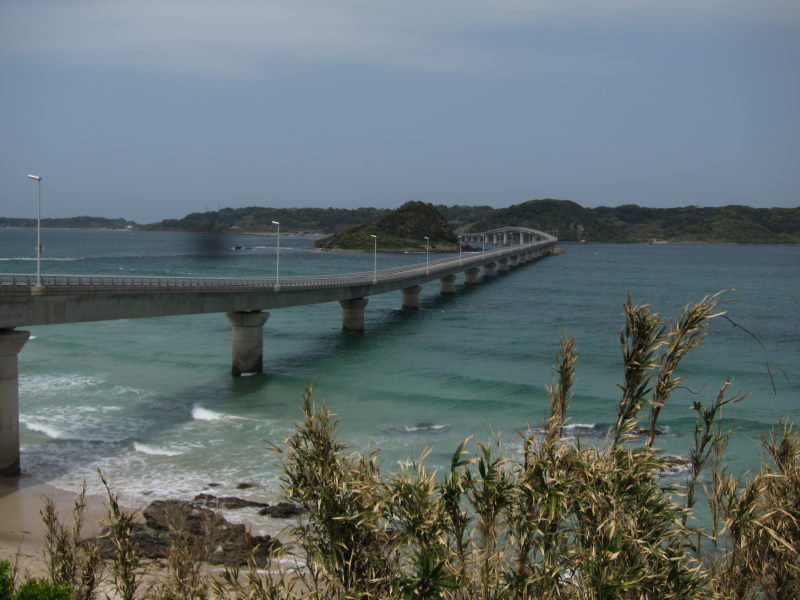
315, 201, 457, 251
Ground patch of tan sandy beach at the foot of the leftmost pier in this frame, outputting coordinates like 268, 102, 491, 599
0, 476, 106, 577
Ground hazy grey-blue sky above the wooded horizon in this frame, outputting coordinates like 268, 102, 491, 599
0, 0, 800, 223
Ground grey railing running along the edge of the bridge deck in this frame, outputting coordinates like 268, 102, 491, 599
0, 238, 555, 289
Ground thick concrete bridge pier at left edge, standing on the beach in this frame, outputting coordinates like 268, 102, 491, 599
0, 329, 31, 476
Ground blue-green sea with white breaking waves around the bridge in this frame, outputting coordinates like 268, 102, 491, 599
0, 229, 800, 532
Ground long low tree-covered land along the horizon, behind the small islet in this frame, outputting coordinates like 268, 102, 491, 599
0, 198, 800, 244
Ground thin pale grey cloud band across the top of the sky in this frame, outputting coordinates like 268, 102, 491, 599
0, 0, 800, 74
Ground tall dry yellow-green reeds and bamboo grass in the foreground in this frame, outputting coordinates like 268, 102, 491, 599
6, 294, 800, 600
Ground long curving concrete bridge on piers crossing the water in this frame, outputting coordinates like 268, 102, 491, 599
0, 227, 557, 475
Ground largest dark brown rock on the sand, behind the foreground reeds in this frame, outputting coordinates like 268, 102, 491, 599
98, 500, 280, 565
